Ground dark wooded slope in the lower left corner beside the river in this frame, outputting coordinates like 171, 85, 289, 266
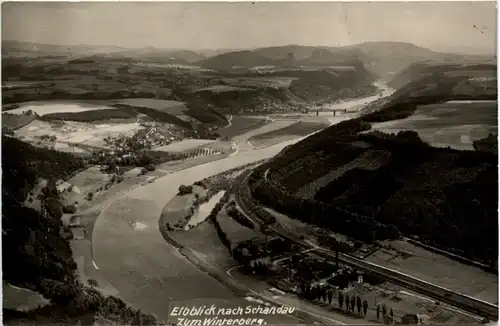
2, 135, 162, 325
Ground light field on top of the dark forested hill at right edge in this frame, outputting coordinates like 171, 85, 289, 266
372, 101, 497, 150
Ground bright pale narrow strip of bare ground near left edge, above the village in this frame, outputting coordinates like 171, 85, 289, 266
8, 102, 117, 116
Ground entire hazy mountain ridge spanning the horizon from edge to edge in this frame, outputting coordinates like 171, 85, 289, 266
2, 41, 496, 77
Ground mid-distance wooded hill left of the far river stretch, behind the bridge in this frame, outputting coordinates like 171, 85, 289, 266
173, 66, 377, 114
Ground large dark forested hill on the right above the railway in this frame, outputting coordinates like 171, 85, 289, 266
245, 67, 498, 265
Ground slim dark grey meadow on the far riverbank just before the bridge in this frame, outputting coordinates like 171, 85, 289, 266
248, 121, 328, 148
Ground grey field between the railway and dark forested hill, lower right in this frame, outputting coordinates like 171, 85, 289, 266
366, 241, 498, 304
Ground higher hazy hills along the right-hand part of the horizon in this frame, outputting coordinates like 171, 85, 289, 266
199, 42, 494, 77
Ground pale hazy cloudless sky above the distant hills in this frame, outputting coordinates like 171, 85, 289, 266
2, 2, 496, 53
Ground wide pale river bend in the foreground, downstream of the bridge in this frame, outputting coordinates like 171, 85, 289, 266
92, 89, 392, 324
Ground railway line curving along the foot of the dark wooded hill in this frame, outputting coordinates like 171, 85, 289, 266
236, 160, 498, 320
